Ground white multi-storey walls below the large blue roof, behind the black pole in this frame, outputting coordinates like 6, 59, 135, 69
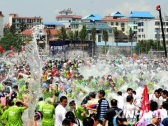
137, 18, 168, 41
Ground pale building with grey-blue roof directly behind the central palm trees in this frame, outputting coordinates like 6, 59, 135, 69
71, 22, 114, 42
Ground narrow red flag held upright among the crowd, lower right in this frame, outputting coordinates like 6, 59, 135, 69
140, 85, 150, 119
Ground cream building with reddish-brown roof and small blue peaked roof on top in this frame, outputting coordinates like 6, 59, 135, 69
102, 12, 129, 35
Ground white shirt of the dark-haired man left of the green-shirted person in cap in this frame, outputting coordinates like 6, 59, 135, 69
55, 104, 67, 126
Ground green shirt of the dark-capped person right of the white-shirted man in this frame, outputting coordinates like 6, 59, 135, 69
74, 106, 86, 121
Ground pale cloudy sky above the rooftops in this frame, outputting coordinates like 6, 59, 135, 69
0, 0, 168, 23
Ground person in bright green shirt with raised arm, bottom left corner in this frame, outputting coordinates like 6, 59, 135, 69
0, 100, 28, 126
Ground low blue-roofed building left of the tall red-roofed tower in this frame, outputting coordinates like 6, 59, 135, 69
43, 22, 64, 29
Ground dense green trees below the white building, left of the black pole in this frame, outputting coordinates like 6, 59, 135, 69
135, 40, 163, 54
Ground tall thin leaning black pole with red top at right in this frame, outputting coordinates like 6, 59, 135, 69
156, 5, 167, 58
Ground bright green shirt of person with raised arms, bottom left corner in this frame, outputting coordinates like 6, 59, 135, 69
1, 106, 25, 126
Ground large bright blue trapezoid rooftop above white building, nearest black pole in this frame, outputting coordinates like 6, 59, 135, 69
128, 11, 155, 19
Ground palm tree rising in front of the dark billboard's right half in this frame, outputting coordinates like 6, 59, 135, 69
79, 25, 88, 56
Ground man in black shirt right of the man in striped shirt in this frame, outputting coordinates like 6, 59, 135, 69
103, 99, 123, 126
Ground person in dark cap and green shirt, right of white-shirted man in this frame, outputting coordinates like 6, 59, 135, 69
69, 100, 86, 122
